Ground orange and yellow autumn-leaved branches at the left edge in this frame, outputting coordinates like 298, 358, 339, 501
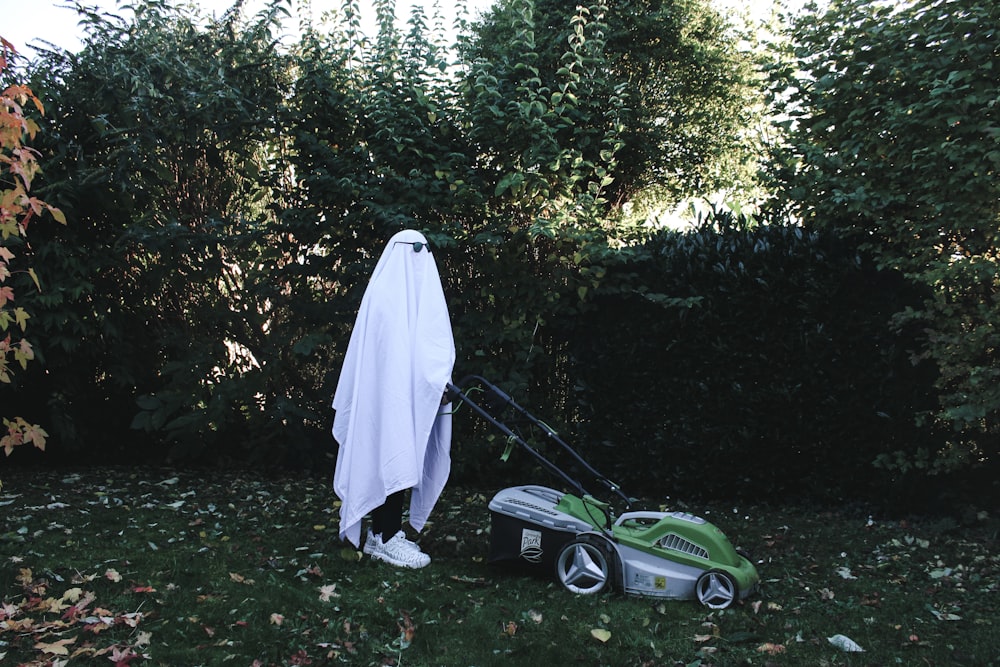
0, 37, 66, 464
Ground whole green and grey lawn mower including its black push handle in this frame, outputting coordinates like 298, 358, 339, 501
447, 375, 759, 609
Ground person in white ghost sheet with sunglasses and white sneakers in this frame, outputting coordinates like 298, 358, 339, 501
333, 230, 455, 567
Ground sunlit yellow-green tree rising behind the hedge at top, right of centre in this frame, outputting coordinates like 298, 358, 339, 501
468, 0, 760, 206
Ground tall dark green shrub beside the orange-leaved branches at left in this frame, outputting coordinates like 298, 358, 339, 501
22, 0, 289, 460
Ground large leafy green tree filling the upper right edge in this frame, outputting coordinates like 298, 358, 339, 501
776, 0, 1000, 478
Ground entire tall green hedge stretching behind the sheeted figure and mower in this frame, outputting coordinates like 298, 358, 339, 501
5, 0, 988, 506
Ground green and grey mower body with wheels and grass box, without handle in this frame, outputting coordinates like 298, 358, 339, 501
489, 485, 759, 609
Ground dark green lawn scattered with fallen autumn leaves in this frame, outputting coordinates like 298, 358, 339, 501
0, 470, 1000, 667
